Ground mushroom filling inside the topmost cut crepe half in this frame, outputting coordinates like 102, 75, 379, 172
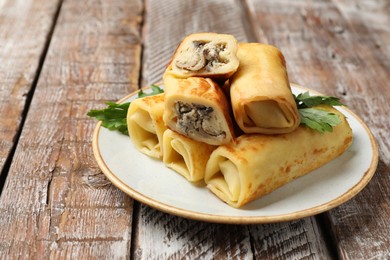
175, 41, 228, 71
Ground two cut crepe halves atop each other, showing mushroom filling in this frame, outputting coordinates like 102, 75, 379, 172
163, 33, 239, 145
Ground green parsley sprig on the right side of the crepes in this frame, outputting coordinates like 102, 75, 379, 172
293, 91, 343, 133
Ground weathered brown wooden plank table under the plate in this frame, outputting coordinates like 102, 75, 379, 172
0, 0, 390, 259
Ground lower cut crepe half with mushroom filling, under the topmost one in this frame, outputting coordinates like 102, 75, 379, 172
163, 75, 234, 145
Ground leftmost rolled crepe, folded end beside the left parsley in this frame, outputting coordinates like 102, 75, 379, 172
127, 94, 167, 159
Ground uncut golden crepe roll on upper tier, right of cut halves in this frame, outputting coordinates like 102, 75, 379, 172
230, 43, 300, 134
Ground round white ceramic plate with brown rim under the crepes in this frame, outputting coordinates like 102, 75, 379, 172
93, 85, 378, 223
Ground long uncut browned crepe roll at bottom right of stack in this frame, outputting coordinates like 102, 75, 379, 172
205, 107, 352, 207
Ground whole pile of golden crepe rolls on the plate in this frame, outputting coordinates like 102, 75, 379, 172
127, 34, 352, 207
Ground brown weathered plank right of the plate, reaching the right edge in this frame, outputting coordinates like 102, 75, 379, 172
247, 0, 390, 259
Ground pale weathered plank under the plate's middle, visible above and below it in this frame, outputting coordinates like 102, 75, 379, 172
133, 0, 330, 259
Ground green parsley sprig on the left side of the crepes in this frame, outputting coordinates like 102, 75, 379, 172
87, 84, 164, 135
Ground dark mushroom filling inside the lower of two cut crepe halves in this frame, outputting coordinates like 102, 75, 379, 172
175, 101, 226, 139
